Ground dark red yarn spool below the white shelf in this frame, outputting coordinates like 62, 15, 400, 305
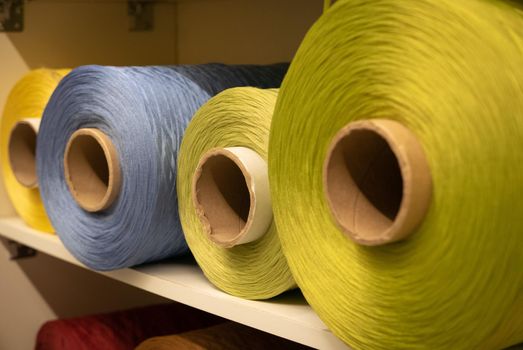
35, 303, 225, 350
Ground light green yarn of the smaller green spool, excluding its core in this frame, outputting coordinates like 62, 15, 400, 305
177, 88, 295, 299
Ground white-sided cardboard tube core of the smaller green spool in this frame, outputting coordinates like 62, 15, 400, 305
192, 147, 272, 248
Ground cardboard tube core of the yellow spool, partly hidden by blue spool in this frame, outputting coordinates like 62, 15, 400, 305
8, 118, 40, 188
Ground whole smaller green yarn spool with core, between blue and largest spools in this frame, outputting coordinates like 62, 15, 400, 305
177, 88, 295, 299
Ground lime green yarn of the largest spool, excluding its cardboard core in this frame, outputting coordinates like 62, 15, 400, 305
269, 0, 523, 349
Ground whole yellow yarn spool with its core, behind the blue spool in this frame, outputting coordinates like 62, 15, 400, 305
0, 69, 69, 232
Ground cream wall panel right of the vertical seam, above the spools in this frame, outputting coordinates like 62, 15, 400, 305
177, 0, 323, 63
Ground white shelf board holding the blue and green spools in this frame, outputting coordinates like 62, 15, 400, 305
0, 218, 348, 350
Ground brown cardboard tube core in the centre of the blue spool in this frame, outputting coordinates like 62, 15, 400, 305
64, 128, 121, 212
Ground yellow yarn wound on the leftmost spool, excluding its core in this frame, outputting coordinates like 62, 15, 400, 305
0, 69, 69, 233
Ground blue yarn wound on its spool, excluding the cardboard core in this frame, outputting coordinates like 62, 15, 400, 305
37, 64, 287, 270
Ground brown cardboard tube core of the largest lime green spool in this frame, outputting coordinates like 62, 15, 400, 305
323, 119, 432, 245
